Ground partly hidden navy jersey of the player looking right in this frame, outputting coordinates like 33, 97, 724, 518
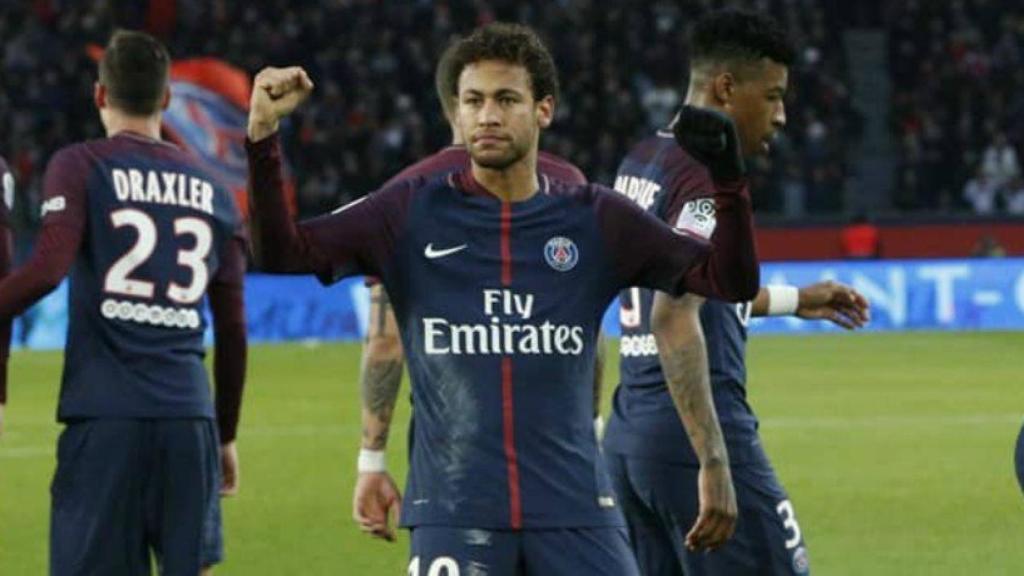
604, 131, 757, 462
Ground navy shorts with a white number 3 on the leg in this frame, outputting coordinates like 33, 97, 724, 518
605, 438, 810, 576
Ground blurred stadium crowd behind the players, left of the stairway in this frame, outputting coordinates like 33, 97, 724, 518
0, 0, 856, 223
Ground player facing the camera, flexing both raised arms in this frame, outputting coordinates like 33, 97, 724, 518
247, 24, 759, 576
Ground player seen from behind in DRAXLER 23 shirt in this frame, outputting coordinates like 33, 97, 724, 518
0, 31, 246, 576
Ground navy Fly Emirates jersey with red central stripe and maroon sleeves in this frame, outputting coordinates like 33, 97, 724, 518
248, 137, 757, 529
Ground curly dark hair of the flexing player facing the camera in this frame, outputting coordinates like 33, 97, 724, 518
447, 23, 558, 100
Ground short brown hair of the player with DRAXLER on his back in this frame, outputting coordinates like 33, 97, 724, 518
99, 30, 171, 116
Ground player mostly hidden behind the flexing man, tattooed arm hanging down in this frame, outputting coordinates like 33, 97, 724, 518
352, 40, 604, 541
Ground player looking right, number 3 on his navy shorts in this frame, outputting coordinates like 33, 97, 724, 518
604, 11, 867, 576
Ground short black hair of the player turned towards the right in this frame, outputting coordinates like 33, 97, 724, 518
690, 10, 797, 73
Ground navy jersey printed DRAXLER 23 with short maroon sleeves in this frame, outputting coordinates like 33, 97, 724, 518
41, 132, 241, 420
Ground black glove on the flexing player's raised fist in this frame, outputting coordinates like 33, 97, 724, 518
672, 106, 746, 181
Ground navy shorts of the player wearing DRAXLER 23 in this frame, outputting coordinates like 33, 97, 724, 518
50, 419, 223, 576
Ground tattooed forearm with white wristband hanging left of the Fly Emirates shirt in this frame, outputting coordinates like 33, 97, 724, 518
352, 284, 403, 541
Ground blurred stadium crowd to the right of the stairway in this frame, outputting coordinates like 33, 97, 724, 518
887, 0, 1024, 214
